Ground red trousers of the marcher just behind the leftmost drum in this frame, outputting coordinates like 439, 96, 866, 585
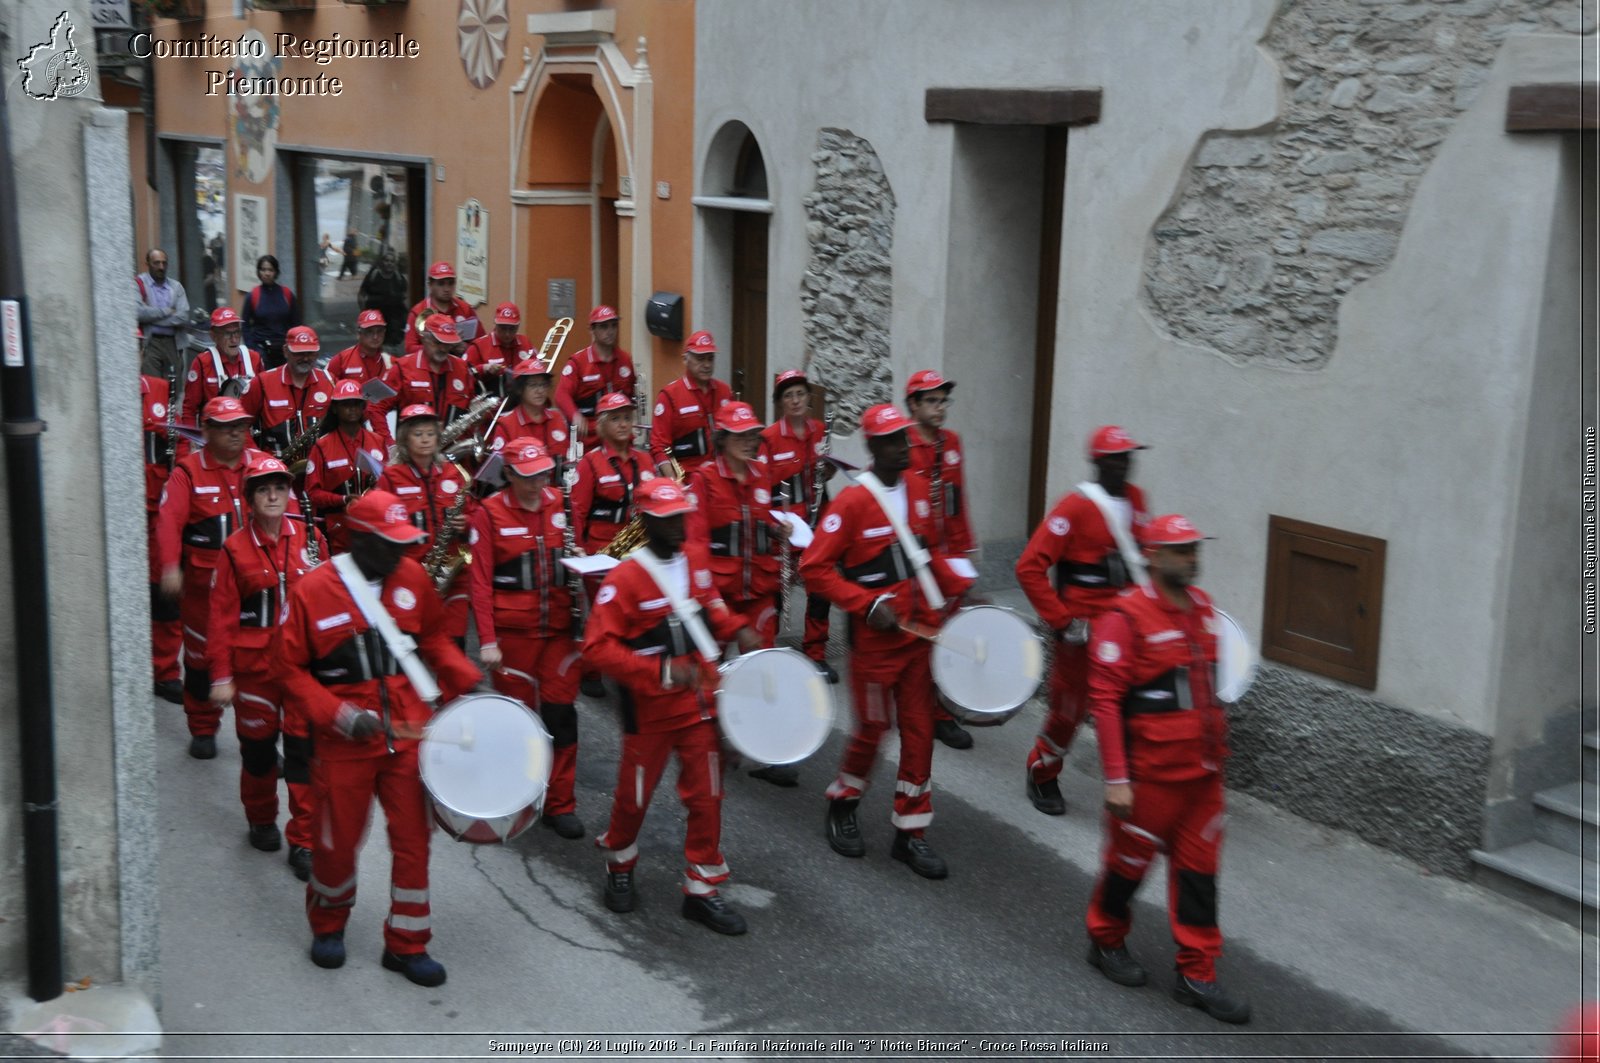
491, 628, 581, 816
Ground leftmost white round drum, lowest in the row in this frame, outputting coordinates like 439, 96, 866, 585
418, 693, 555, 844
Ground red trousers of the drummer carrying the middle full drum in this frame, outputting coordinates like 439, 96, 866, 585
595, 720, 728, 897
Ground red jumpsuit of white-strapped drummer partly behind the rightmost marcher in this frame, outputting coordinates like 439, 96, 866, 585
1016, 483, 1150, 783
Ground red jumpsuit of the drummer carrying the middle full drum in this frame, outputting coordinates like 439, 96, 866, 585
584, 548, 742, 897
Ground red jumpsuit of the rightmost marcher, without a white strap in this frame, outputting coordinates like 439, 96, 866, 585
1088, 588, 1227, 981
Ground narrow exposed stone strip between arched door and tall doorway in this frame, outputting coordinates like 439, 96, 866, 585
800, 128, 894, 435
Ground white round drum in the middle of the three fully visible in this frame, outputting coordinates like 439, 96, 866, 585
717, 648, 834, 764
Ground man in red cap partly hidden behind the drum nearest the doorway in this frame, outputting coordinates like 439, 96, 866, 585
906, 370, 976, 749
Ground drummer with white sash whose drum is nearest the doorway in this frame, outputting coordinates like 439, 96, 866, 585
800, 403, 973, 879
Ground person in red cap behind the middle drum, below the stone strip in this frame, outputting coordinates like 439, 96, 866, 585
762, 370, 838, 684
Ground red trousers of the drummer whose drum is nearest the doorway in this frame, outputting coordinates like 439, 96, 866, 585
827, 640, 936, 837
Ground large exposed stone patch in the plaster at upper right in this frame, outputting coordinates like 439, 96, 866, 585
1144, 0, 1594, 368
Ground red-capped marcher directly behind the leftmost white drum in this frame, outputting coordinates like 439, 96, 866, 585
467, 435, 584, 837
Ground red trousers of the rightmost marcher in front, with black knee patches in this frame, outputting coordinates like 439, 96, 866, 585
1086, 772, 1222, 981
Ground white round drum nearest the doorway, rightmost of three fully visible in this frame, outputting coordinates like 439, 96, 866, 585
933, 605, 1045, 725
